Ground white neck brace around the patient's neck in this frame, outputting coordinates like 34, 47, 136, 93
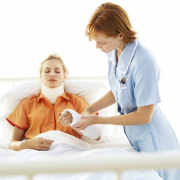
41, 83, 64, 104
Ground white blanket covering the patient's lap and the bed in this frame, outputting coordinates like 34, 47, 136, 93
0, 131, 162, 180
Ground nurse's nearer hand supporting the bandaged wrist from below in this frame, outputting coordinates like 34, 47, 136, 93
72, 115, 99, 131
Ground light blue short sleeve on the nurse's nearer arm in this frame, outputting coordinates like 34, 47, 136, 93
133, 57, 161, 107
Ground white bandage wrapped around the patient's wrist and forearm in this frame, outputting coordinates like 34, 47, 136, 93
62, 109, 102, 139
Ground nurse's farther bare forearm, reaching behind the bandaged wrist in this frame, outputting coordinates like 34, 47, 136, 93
81, 90, 116, 115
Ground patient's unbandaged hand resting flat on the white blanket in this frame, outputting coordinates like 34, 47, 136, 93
27, 138, 54, 151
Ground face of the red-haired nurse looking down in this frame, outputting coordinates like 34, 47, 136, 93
94, 32, 124, 53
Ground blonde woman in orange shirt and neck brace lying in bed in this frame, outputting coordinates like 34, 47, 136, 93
6, 55, 101, 150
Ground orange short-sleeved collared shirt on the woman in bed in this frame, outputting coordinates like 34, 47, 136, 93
6, 93, 88, 139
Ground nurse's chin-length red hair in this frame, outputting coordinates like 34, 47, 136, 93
85, 3, 137, 42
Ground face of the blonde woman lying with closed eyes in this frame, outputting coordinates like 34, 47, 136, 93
41, 59, 64, 88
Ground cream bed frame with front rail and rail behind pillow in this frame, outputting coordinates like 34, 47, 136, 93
0, 77, 180, 180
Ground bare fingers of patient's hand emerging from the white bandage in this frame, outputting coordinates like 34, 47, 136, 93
58, 112, 73, 126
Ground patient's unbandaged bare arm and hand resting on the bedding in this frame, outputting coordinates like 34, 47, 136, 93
9, 127, 53, 151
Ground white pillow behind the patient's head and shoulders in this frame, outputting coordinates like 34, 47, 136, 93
0, 79, 109, 142
